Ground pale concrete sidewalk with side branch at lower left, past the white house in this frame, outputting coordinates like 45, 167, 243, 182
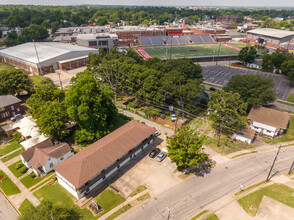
0, 161, 40, 208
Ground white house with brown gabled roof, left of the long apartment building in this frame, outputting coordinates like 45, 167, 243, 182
20, 140, 74, 176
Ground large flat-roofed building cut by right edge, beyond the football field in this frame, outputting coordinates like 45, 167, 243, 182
246, 28, 294, 48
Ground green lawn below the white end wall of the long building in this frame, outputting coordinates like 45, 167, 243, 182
34, 183, 97, 220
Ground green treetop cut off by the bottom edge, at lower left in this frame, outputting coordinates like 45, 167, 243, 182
18, 200, 82, 220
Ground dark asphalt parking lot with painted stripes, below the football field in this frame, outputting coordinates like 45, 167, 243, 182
202, 66, 292, 100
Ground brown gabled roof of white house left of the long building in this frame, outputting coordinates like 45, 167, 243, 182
21, 140, 71, 169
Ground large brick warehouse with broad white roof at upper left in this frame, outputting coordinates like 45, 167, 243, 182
0, 42, 98, 74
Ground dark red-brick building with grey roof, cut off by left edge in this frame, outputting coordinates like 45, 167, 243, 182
0, 95, 23, 122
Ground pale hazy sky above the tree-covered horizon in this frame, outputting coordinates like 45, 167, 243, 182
0, 0, 294, 7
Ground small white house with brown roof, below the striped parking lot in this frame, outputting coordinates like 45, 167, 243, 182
248, 105, 290, 137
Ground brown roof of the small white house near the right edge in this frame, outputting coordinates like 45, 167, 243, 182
248, 105, 290, 129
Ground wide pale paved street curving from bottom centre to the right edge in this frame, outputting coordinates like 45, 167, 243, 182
121, 147, 294, 220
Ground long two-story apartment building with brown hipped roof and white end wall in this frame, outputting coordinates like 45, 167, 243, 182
54, 121, 156, 199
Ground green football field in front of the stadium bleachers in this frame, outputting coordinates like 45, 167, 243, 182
136, 43, 263, 59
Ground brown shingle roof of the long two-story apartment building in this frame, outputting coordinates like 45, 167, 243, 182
54, 121, 155, 188
